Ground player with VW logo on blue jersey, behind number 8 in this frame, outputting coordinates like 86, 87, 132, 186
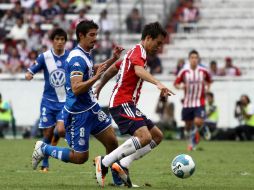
25, 28, 69, 172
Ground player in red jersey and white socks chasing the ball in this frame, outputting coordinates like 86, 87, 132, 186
95, 22, 173, 187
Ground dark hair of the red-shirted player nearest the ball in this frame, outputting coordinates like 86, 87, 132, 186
141, 22, 167, 40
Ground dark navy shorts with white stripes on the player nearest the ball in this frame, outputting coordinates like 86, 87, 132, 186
109, 103, 154, 135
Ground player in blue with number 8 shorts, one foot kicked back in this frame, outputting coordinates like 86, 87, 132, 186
32, 20, 123, 186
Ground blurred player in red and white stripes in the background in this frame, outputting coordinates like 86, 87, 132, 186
174, 50, 211, 150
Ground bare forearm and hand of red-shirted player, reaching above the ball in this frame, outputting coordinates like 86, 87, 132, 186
134, 65, 174, 96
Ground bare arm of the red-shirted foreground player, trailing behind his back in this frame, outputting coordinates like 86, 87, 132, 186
95, 64, 119, 98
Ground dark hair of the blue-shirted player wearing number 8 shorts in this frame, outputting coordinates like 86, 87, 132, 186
76, 20, 99, 42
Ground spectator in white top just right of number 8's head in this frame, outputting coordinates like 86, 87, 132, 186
99, 9, 114, 33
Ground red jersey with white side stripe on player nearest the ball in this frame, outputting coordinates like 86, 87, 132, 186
109, 44, 147, 107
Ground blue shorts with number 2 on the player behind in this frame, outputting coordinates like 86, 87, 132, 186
39, 98, 64, 129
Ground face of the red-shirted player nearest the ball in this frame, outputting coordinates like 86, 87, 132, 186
146, 35, 165, 55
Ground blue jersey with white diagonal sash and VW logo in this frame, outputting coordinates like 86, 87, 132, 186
28, 49, 69, 102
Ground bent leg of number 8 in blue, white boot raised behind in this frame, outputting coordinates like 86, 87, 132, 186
32, 108, 92, 169
